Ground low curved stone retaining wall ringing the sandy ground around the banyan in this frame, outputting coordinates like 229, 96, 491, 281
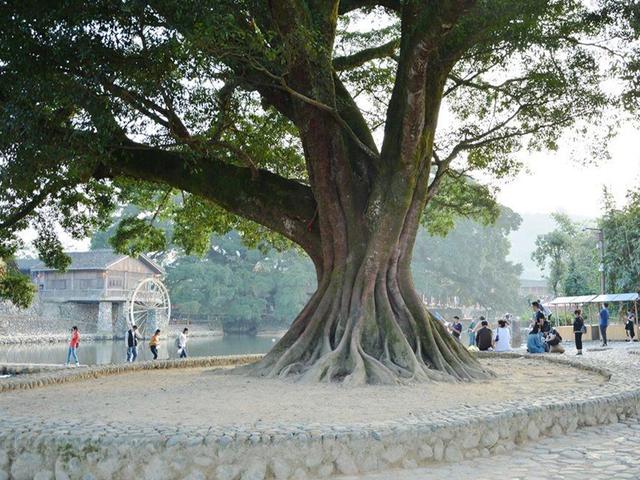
0, 354, 640, 480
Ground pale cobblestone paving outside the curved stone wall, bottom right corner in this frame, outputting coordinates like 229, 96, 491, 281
336, 419, 640, 480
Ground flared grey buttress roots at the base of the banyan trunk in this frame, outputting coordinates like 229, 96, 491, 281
236, 271, 492, 385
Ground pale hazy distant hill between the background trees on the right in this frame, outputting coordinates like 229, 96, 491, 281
508, 213, 588, 280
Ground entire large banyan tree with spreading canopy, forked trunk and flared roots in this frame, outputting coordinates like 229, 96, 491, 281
0, 0, 628, 384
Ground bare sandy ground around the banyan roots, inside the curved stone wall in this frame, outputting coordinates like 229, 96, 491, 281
0, 359, 605, 426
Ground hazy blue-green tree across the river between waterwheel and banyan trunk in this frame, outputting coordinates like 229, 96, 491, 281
167, 232, 316, 329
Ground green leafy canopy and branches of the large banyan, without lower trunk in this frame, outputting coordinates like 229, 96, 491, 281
0, 0, 627, 304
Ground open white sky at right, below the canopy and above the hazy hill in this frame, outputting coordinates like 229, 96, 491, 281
498, 124, 640, 218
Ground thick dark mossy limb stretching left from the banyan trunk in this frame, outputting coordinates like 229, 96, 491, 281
105, 140, 321, 262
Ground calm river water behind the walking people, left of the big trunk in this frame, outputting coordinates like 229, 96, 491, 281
0, 335, 278, 365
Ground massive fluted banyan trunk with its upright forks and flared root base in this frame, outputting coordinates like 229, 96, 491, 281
235, 19, 491, 385
